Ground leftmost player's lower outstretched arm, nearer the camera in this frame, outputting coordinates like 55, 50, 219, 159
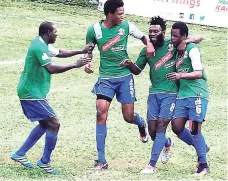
44, 57, 91, 74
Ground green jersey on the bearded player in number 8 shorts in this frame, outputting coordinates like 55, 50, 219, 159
135, 38, 178, 93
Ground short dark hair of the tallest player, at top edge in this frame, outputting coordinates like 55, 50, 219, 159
104, 0, 124, 16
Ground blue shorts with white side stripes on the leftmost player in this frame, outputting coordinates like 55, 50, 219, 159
20, 99, 56, 122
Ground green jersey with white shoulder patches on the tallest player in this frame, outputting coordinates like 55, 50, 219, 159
86, 21, 143, 78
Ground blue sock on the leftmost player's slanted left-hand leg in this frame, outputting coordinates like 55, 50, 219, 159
16, 124, 46, 156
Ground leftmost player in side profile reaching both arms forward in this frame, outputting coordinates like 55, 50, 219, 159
11, 22, 91, 174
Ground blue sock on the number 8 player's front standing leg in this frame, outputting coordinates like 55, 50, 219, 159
150, 133, 167, 167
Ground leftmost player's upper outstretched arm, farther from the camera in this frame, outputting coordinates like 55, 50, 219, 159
57, 43, 94, 58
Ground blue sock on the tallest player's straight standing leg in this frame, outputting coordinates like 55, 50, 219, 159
96, 124, 107, 163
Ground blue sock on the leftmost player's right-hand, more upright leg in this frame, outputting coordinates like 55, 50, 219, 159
41, 130, 58, 164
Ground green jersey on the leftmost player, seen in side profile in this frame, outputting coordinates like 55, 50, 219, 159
17, 37, 51, 100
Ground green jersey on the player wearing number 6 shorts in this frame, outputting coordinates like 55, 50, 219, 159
176, 43, 209, 99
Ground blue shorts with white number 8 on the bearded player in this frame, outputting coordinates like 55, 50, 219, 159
147, 93, 177, 121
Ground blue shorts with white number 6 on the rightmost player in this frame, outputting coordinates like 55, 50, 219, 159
173, 97, 208, 122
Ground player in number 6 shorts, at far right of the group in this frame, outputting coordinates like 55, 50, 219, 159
167, 22, 210, 175
